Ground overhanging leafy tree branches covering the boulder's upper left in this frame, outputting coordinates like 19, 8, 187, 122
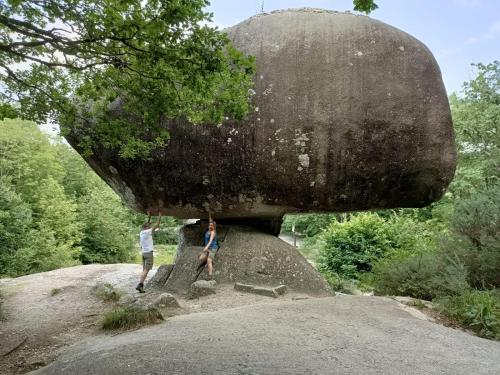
0, 0, 254, 157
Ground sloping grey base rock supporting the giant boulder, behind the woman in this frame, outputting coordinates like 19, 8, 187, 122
165, 223, 330, 295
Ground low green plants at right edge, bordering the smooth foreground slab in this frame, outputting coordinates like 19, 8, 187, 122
436, 289, 500, 339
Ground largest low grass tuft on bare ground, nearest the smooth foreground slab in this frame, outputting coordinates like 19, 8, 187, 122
101, 305, 164, 330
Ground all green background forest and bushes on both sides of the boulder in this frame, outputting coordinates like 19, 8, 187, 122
0, 62, 500, 338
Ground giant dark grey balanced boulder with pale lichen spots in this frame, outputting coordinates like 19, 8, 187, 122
68, 9, 456, 226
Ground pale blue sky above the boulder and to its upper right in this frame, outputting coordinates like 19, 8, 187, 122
204, 0, 500, 94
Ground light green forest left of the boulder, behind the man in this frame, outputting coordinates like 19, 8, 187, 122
0, 119, 181, 276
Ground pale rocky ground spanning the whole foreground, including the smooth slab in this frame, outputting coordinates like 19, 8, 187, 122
0, 264, 500, 375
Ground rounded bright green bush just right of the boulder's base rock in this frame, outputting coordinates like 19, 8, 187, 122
318, 213, 425, 279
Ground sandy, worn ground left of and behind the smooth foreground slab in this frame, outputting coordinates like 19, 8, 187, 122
0, 264, 316, 375
